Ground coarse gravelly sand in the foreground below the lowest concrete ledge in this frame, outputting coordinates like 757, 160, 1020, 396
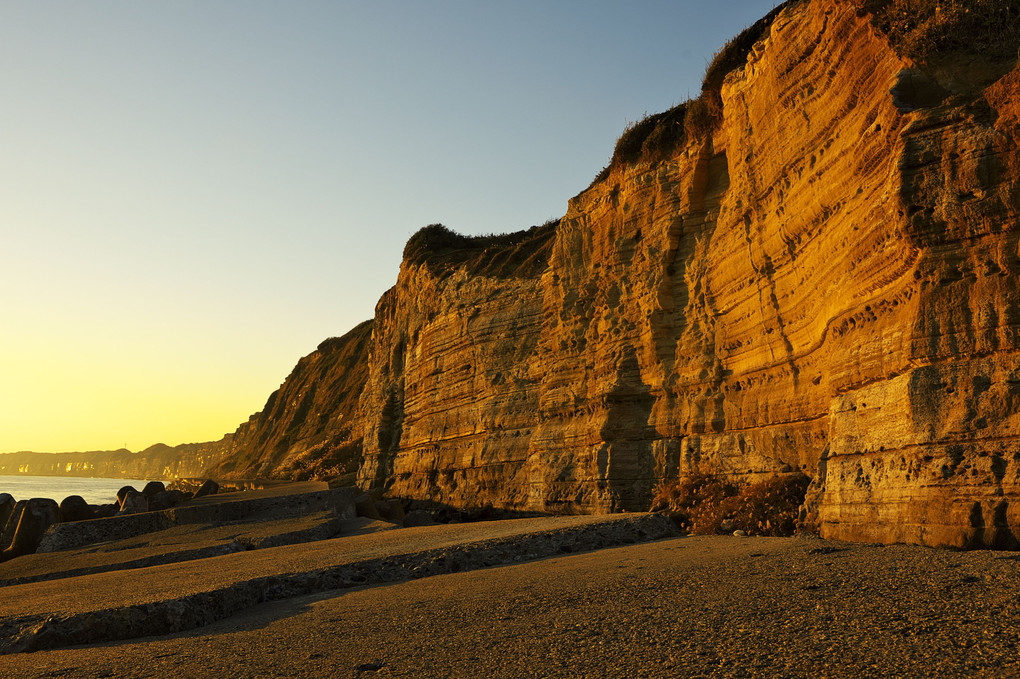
9, 536, 1020, 678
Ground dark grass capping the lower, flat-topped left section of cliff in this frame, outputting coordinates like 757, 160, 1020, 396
404, 219, 560, 278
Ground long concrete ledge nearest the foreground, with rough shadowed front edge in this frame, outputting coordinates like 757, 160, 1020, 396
0, 514, 679, 654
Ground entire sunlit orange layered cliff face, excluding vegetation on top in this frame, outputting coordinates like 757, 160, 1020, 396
360, 0, 1020, 544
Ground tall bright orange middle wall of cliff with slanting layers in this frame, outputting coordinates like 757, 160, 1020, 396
531, 3, 917, 510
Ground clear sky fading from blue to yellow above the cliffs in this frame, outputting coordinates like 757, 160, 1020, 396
0, 0, 777, 453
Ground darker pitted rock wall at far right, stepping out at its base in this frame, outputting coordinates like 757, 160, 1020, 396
820, 46, 1020, 549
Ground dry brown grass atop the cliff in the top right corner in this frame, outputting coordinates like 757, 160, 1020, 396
851, 0, 1020, 61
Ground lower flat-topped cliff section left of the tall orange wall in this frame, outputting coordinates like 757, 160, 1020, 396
359, 224, 555, 508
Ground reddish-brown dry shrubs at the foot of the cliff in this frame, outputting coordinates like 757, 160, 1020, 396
652, 474, 810, 537
